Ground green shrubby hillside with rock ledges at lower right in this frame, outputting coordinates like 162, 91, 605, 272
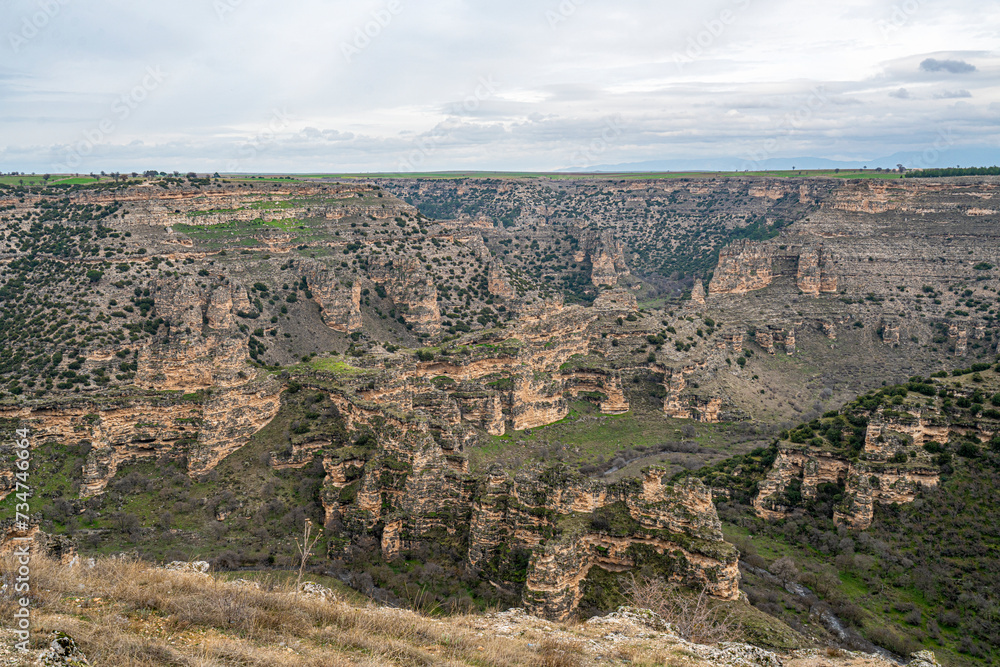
690, 364, 1000, 664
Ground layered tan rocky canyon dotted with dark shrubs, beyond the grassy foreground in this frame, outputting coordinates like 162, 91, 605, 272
0, 177, 1000, 664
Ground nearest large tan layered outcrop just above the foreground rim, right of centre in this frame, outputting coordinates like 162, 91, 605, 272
469, 469, 739, 619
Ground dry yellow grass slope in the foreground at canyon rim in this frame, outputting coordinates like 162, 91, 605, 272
0, 558, 908, 667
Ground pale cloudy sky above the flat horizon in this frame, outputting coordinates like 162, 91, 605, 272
0, 0, 1000, 173
